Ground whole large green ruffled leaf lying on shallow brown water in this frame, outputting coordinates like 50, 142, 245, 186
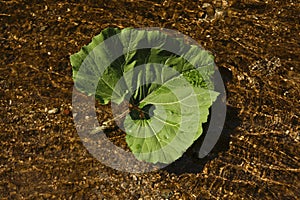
70, 28, 217, 163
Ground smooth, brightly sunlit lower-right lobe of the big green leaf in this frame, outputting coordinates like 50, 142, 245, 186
124, 76, 218, 164
